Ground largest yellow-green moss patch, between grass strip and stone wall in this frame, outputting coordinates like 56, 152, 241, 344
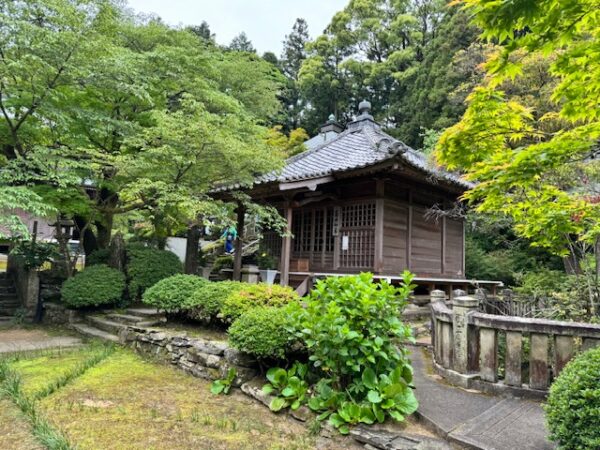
39, 350, 324, 450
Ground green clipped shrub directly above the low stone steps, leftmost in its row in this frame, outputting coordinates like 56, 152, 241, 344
142, 275, 210, 311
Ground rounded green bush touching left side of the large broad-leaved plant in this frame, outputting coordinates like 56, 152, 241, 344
229, 306, 293, 359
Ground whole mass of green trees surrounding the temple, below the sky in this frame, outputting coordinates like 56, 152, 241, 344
0, 0, 600, 298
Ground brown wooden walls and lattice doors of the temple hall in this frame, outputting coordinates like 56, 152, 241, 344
264, 174, 464, 278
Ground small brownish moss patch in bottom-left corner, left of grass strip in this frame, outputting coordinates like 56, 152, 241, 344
0, 398, 43, 450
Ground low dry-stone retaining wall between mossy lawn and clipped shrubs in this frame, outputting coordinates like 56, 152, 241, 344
119, 326, 258, 387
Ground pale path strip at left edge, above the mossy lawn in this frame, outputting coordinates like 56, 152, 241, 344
0, 328, 81, 353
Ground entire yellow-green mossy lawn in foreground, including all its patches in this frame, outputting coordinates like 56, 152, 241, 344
0, 345, 357, 450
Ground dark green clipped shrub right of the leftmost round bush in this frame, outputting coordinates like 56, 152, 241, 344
127, 244, 183, 299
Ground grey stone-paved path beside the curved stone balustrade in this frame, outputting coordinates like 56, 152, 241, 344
411, 347, 555, 450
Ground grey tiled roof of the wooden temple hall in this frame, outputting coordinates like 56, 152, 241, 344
213, 103, 472, 190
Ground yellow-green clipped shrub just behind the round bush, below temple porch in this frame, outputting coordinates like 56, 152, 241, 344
221, 283, 298, 321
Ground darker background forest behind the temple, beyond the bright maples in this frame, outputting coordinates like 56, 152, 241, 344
206, 0, 565, 289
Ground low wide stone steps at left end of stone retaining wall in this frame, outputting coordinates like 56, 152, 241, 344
73, 307, 166, 342
